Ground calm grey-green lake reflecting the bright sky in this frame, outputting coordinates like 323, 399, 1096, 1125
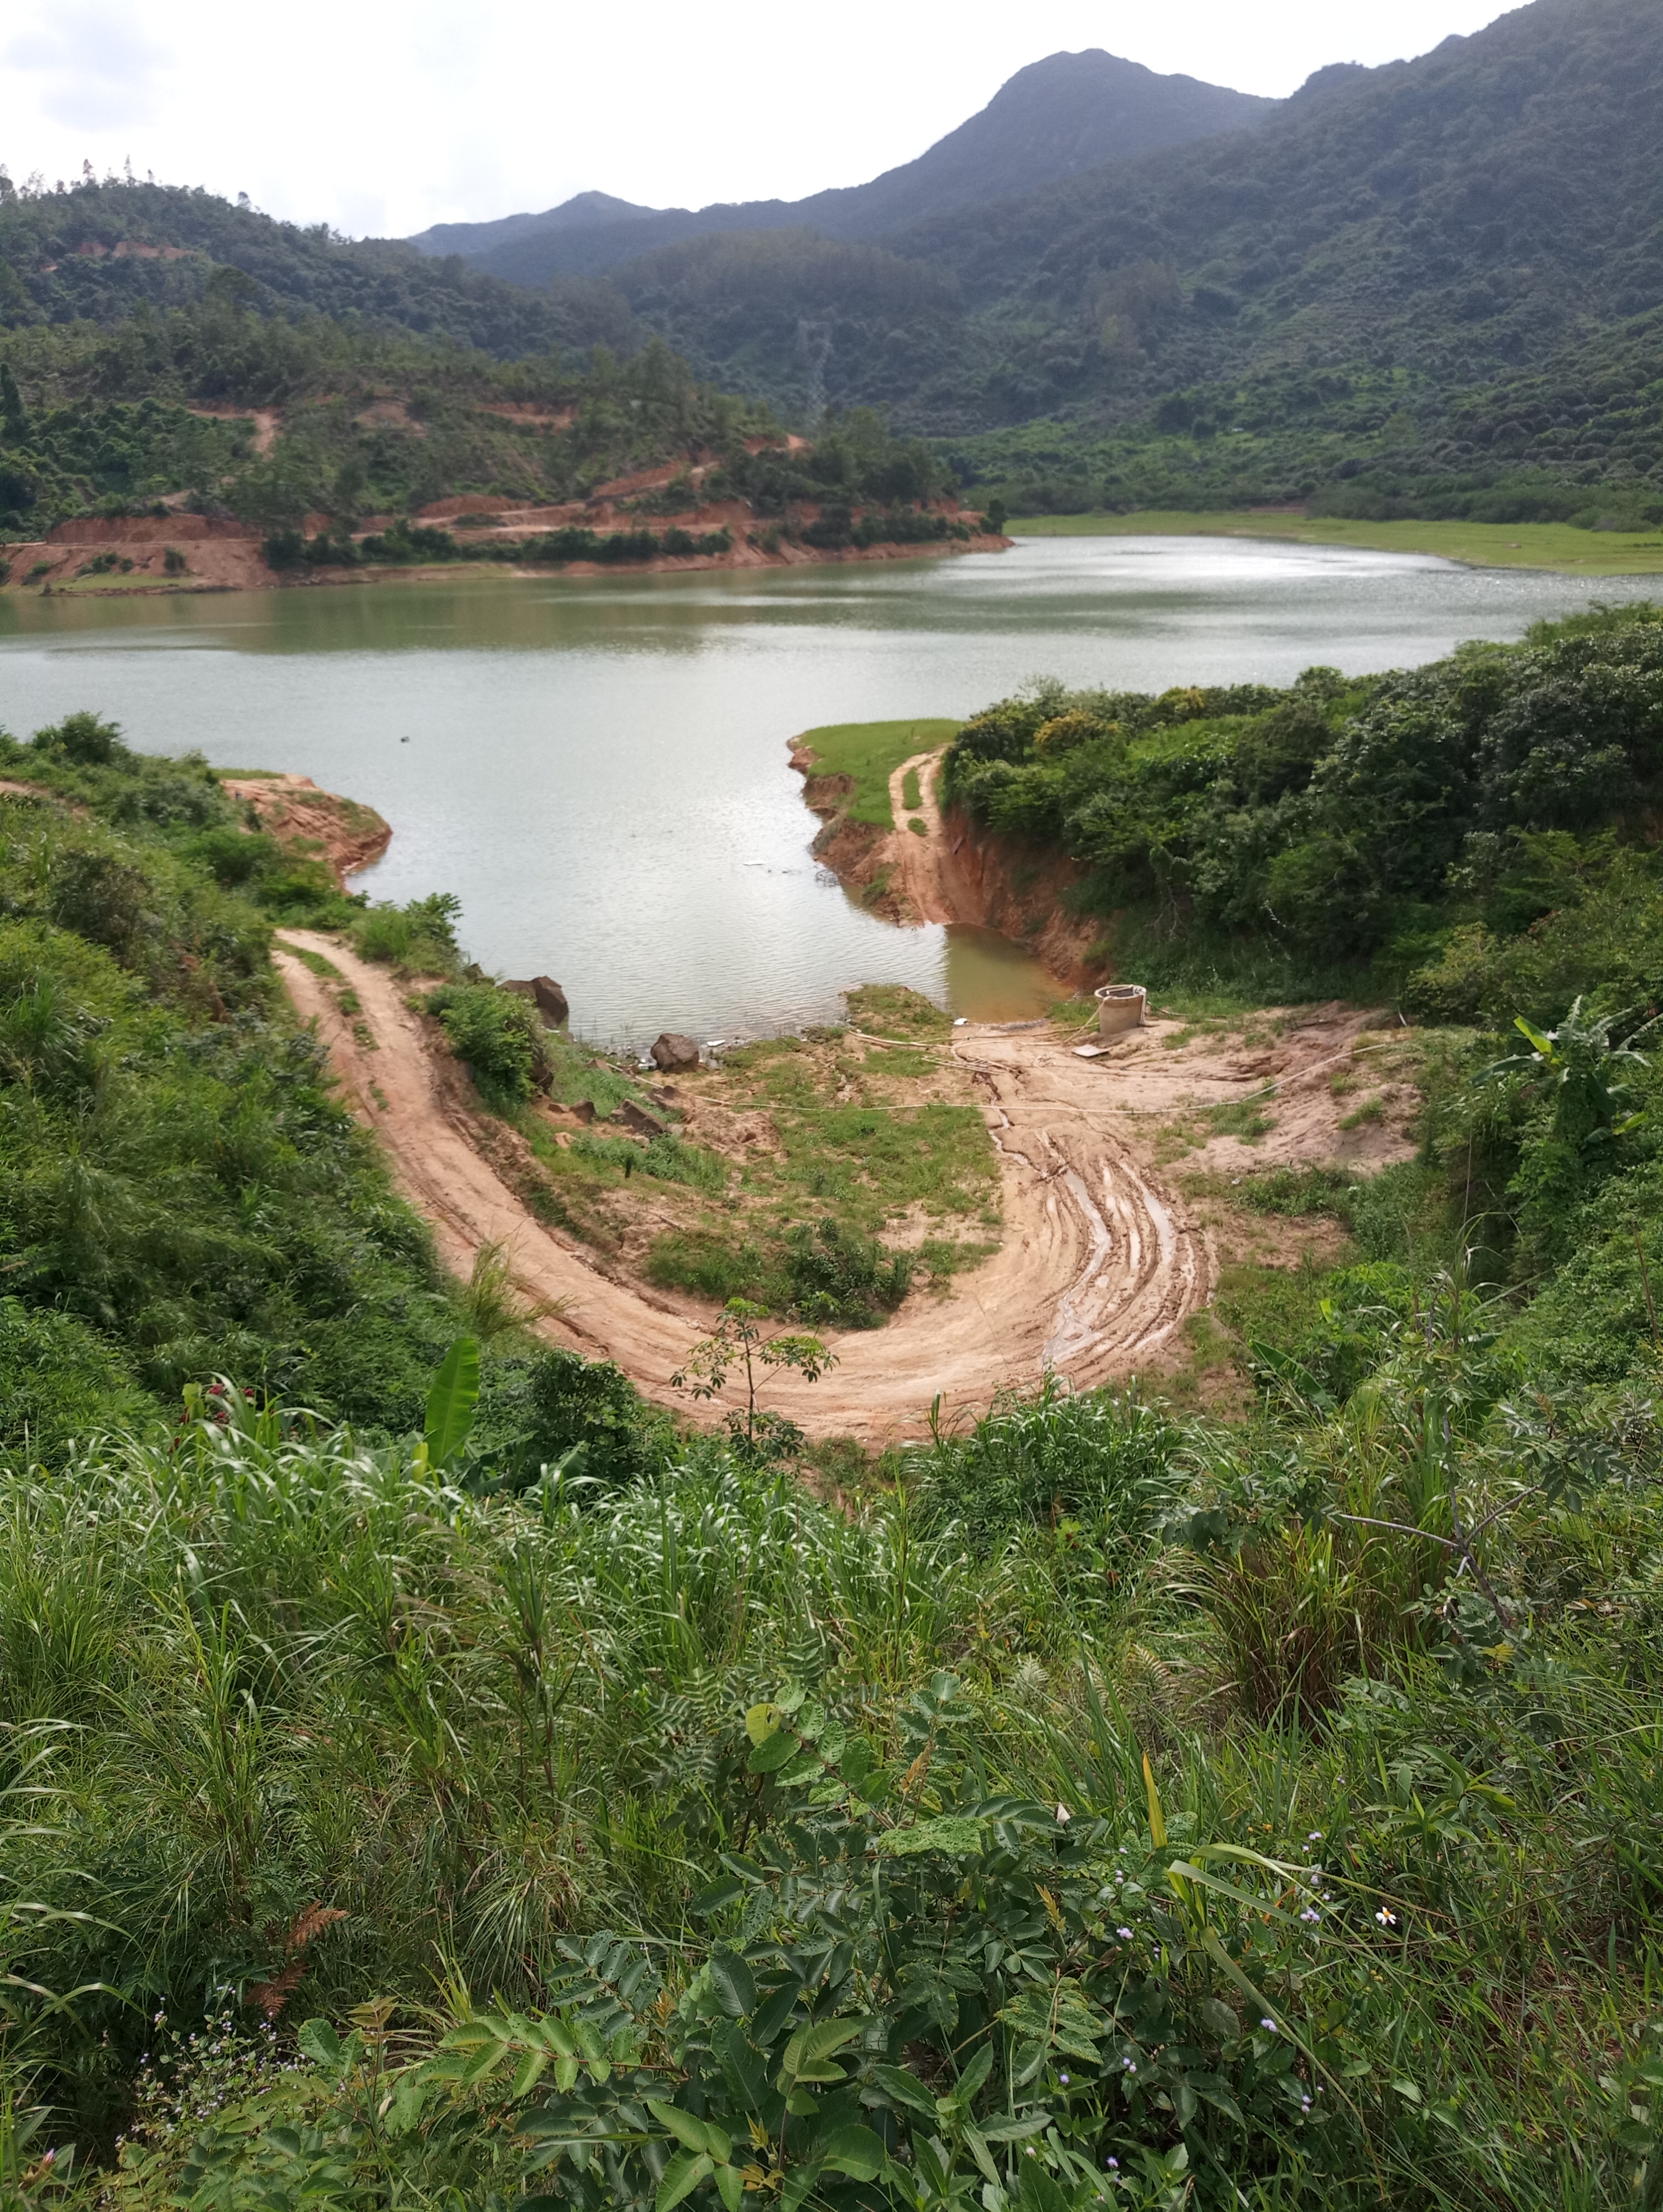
0, 538, 1659, 1044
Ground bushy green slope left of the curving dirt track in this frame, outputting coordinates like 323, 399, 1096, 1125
0, 714, 637, 1464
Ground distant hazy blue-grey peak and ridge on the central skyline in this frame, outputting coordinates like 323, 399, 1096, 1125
411, 49, 1278, 283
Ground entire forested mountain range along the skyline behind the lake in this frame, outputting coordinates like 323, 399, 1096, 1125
0, 0, 1663, 522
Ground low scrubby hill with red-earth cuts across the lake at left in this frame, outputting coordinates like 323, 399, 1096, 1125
0, 226, 969, 568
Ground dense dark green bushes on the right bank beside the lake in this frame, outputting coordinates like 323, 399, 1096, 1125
944, 608, 1663, 991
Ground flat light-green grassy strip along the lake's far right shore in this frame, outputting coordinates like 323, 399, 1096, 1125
1004, 511, 1663, 575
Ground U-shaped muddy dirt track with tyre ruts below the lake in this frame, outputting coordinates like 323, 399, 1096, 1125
274, 925, 1214, 1444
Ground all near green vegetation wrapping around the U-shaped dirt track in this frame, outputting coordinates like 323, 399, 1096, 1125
0, 613, 1663, 2212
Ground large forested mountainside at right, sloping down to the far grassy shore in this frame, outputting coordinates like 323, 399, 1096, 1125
597, 0, 1663, 513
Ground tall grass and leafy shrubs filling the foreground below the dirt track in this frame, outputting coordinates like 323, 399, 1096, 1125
0, 1281, 1663, 2212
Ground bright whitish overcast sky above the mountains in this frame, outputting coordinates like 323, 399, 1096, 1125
0, 0, 1499, 234
